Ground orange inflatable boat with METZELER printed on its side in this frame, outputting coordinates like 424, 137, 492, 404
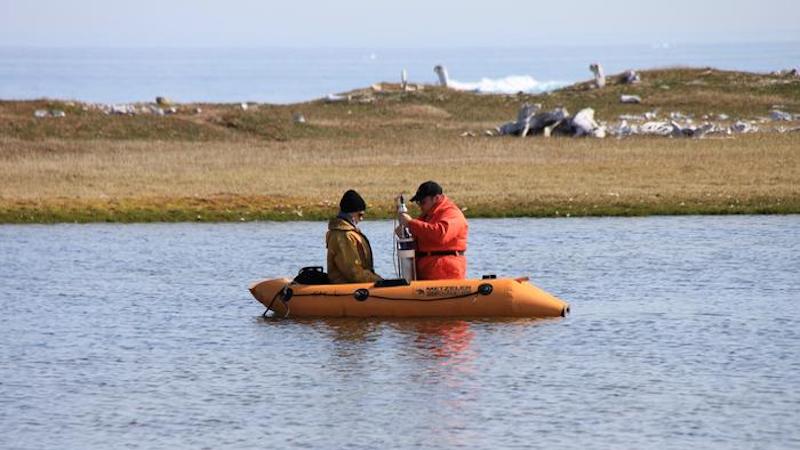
250, 278, 569, 317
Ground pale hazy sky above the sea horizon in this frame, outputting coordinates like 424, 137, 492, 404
0, 0, 800, 48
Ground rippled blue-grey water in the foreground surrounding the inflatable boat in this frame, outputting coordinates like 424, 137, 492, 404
0, 216, 800, 449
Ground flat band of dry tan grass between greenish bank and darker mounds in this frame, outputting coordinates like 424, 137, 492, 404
0, 134, 800, 221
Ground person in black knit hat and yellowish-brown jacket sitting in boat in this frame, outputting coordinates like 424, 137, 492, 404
325, 189, 381, 284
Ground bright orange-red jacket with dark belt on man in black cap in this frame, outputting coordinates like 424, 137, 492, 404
408, 196, 468, 280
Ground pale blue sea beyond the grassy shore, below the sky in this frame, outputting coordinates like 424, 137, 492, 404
0, 42, 800, 103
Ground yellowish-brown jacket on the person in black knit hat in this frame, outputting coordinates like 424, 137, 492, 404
325, 217, 381, 284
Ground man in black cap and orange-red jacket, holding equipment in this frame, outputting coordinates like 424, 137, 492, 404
400, 181, 468, 280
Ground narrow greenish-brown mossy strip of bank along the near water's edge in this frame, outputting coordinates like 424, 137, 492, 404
0, 194, 800, 225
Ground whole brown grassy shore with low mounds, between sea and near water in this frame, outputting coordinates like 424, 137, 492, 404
0, 69, 800, 223
